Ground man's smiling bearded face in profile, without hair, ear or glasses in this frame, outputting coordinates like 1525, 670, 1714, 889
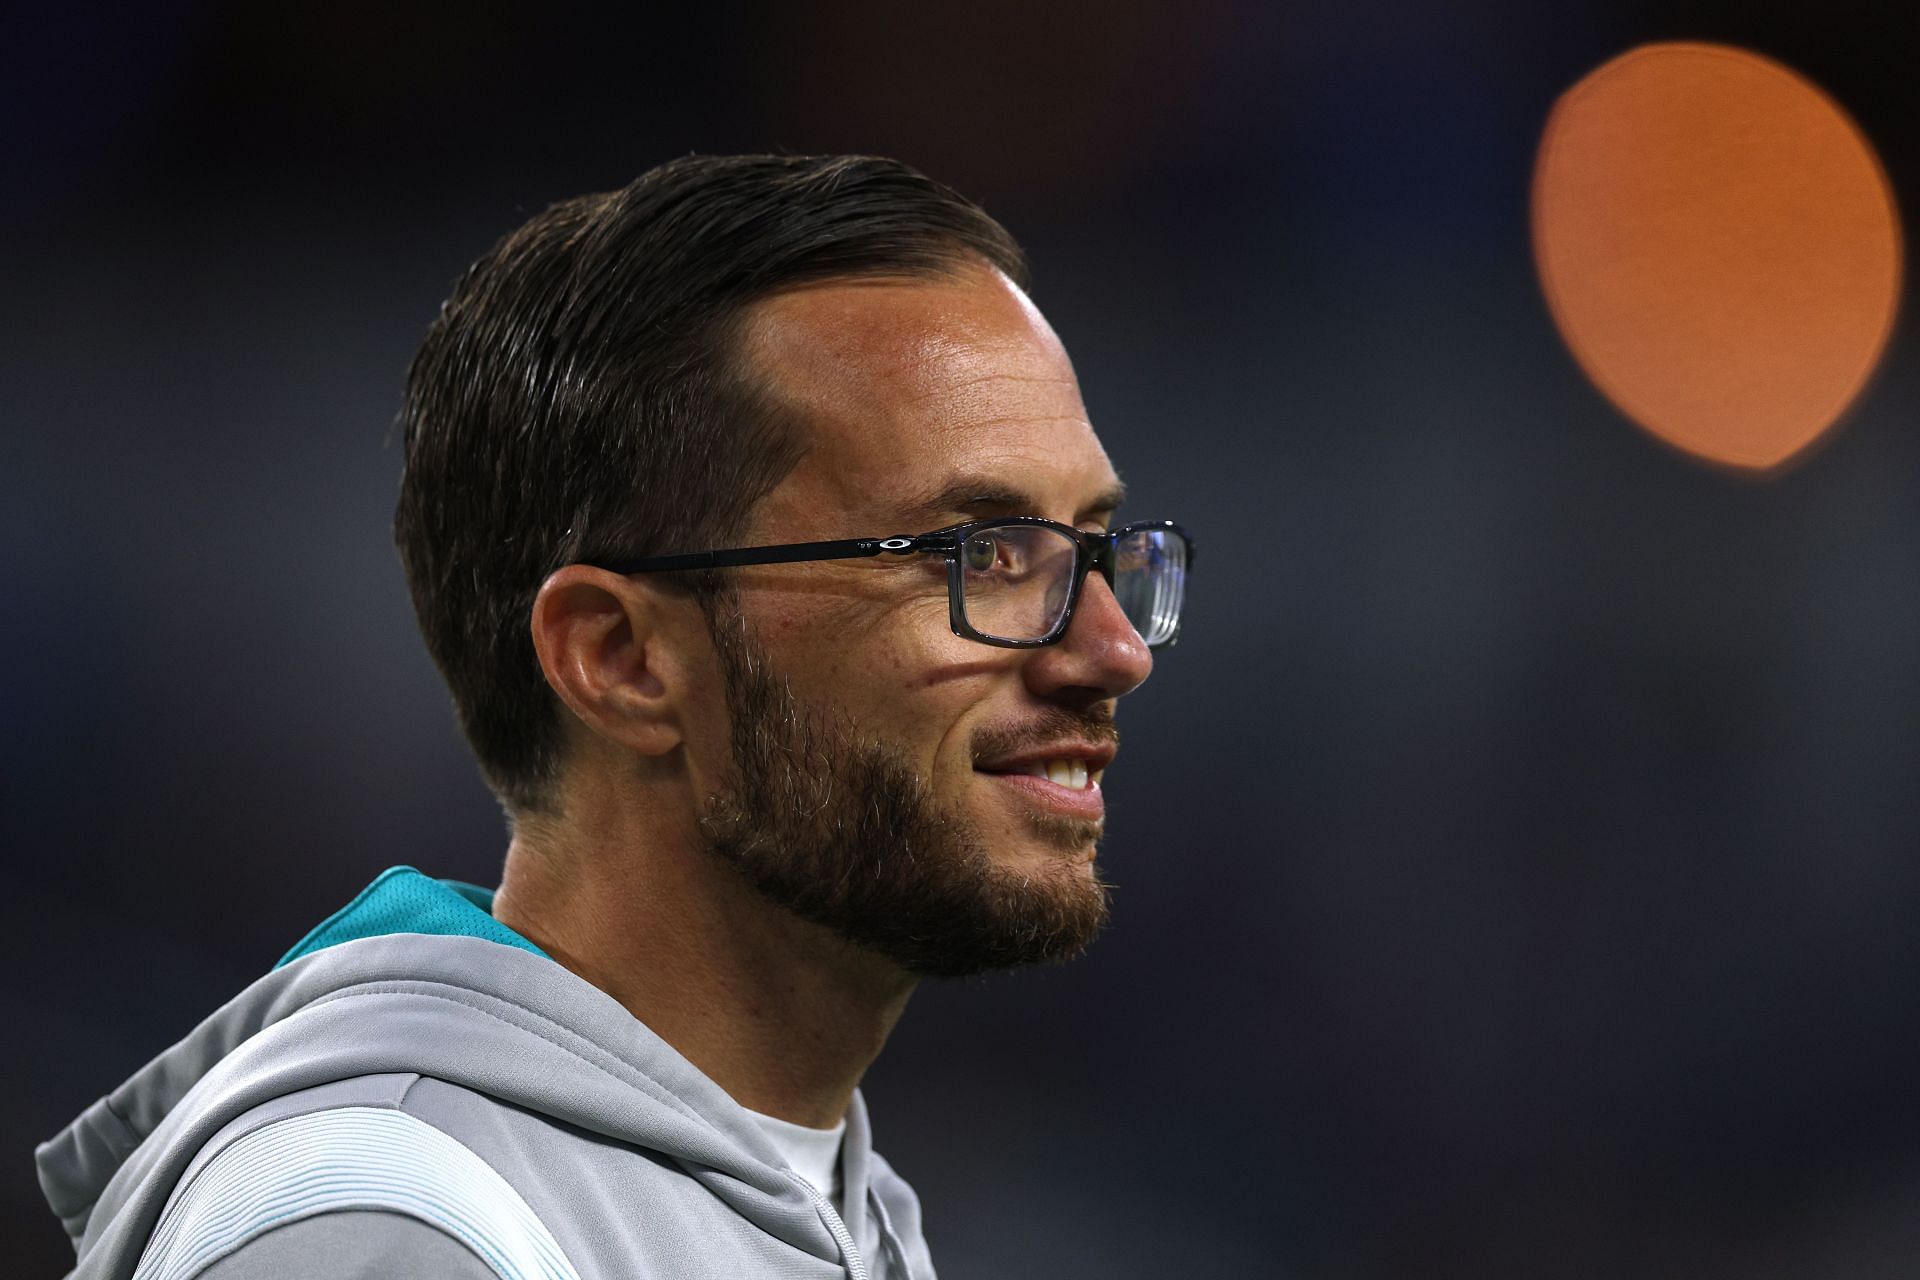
697, 267, 1152, 973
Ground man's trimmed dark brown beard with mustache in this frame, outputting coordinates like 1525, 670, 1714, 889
701, 593, 1116, 977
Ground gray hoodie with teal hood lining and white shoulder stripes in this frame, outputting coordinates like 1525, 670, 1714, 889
38, 867, 933, 1280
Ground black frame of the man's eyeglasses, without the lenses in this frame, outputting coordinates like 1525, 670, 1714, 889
593, 516, 1194, 649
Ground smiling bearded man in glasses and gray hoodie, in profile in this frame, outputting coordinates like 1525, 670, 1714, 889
40, 157, 1188, 1280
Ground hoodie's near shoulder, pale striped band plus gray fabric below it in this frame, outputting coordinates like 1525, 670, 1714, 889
134, 1105, 574, 1280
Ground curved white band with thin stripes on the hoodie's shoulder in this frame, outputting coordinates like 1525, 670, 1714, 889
132, 1107, 580, 1280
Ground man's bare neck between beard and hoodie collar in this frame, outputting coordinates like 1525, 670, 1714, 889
493, 796, 914, 1128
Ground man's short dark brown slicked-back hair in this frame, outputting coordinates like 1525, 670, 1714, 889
394, 155, 1027, 812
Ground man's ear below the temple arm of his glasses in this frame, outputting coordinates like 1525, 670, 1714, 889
532, 564, 684, 756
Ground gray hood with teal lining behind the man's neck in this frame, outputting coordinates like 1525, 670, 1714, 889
36, 867, 872, 1278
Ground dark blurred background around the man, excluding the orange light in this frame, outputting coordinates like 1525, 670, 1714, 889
0, 0, 1920, 1280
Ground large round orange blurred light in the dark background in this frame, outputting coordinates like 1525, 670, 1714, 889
1534, 44, 1901, 468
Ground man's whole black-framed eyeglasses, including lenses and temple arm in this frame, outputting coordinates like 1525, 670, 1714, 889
597, 516, 1194, 649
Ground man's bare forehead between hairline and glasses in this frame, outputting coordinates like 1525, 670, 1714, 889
745, 265, 1117, 539
